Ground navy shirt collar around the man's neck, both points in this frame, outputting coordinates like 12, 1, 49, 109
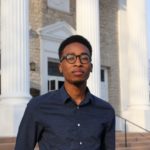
60, 86, 92, 105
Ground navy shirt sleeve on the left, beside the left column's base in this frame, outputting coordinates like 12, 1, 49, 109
15, 100, 41, 150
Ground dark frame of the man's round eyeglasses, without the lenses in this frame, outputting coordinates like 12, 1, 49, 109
60, 53, 91, 64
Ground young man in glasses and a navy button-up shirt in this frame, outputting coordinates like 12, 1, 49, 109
15, 35, 115, 150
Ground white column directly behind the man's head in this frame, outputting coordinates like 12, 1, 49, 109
76, 0, 100, 97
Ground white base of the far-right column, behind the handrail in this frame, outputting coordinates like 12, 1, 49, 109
123, 106, 150, 132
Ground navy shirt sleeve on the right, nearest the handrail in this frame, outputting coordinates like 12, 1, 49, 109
101, 109, 115, 150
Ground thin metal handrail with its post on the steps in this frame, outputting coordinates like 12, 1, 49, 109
116, 114, 150, 147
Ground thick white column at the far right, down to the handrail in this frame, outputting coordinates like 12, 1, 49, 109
127, 0, 150, 129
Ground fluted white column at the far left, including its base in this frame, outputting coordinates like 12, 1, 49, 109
0, 0, 30, 136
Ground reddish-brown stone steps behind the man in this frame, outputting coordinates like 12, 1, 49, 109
0, 132, 150, 150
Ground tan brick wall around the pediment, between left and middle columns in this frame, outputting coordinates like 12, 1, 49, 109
29, 0, 76, 94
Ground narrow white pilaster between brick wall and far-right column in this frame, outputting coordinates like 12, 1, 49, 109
118, 0, 130, 111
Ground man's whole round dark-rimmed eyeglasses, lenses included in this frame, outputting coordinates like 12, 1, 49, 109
60, 54, 91, 64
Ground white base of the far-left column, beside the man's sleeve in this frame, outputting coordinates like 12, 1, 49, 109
0, 98, 29, 137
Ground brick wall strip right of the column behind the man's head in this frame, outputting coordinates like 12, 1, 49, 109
100, 0, 120, 111
